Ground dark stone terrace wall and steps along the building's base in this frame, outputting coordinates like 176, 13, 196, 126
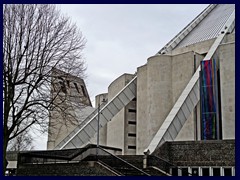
16, 140, 235, 176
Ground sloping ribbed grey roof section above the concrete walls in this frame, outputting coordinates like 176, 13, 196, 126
157, 4, 235, 54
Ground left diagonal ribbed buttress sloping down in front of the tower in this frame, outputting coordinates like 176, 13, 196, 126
55, 76, 137, 149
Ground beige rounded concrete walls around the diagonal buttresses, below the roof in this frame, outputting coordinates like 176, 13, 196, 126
92, 33, 235, 154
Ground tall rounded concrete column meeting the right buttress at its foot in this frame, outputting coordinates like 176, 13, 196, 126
147, 55, 173, 149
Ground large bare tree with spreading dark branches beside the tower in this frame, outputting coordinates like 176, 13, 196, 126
3, 4, 86, 172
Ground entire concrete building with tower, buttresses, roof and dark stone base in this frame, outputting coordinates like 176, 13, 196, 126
3, 4, 232, 176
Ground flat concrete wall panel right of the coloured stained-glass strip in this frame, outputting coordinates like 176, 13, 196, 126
218, 43, 235, 139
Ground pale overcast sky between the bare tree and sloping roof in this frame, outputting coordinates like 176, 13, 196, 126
34, 4, 208, 149
